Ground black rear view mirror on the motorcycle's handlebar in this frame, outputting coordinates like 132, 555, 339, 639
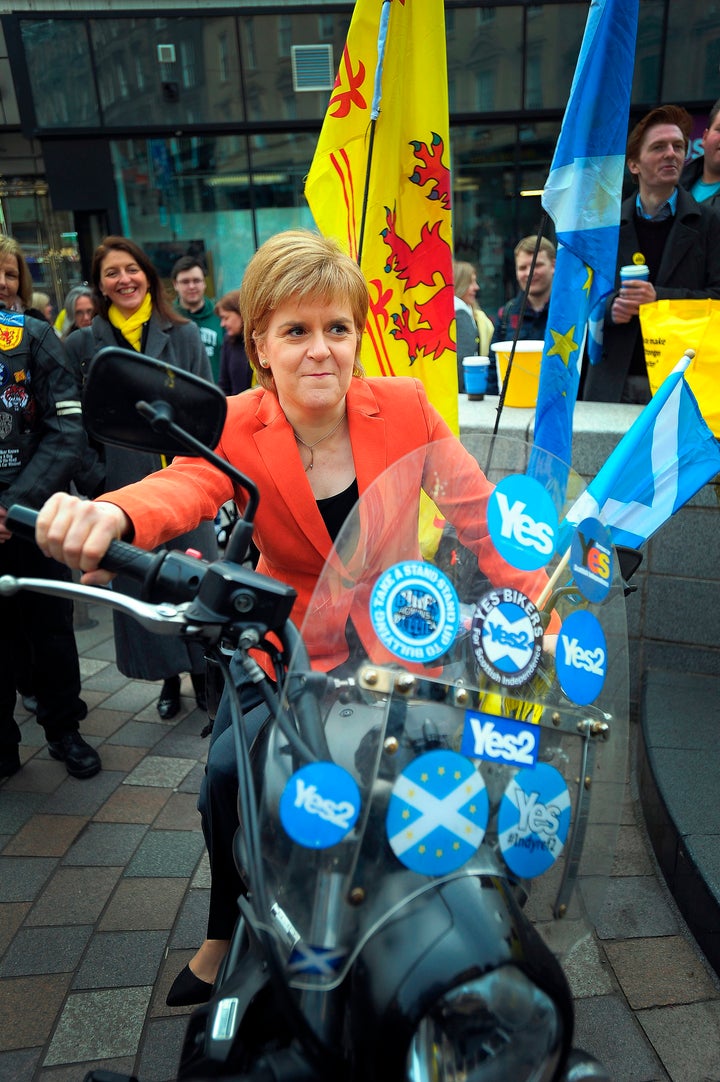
82, 346, 227, 454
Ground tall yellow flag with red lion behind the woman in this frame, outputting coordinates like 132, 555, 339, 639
305, 0, 458, 433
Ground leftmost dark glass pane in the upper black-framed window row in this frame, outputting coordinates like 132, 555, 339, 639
21, 18, 101, 128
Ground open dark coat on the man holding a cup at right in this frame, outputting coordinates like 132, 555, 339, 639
584, 188, 720, 403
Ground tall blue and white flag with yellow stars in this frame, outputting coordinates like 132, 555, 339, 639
534, 0, 638, 465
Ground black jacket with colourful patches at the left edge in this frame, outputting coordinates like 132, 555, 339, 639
0, 309, 86, 507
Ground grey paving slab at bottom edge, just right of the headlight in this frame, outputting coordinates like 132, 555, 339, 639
571, 995, 669, 1082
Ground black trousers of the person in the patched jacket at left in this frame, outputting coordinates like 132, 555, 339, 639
0, 537, 88, 750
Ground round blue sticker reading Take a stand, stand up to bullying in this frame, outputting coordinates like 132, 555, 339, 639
370, 560, 460, 662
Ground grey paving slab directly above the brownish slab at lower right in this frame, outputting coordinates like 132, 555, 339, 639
597, 875, 679, 939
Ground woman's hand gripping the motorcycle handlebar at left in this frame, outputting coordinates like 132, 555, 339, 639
35, 492, 132, 586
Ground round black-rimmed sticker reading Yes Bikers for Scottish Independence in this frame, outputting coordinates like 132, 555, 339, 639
470, 586, 542, 687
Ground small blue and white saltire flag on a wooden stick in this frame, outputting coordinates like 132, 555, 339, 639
561, 351, 720, 549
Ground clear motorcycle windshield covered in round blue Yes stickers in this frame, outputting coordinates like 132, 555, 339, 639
260, 437, 628, 989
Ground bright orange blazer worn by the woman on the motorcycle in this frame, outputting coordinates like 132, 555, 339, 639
102, 377, 547, 670
